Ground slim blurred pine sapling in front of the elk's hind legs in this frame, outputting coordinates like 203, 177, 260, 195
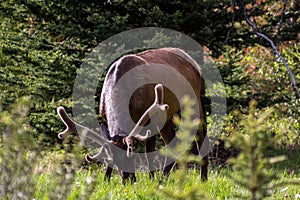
158, 96, 207, 200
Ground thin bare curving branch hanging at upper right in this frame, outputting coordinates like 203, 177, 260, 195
234, 0, 300, 97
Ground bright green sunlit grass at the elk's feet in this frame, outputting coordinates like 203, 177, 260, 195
34, 153, 300, 200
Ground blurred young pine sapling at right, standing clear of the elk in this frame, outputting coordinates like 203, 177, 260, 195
225, 100, 298, 200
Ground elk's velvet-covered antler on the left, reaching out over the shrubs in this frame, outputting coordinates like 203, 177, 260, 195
57, 106, 112, 162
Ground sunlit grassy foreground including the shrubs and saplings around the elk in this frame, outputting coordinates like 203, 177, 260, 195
0, 97, 300, 200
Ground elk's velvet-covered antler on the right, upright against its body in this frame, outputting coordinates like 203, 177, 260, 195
123, 84, 169, 157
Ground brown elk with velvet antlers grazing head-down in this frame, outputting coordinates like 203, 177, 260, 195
57, 48, 208, 181
